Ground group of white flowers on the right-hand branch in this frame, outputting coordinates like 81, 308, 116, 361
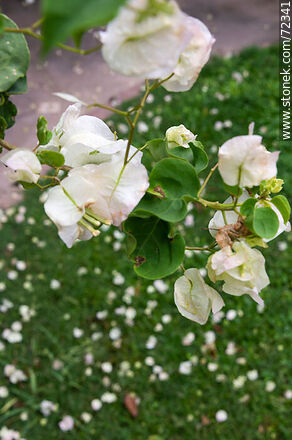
174, 134, 291, 324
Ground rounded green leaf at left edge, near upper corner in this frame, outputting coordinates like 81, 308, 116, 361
0, 14, 30, 92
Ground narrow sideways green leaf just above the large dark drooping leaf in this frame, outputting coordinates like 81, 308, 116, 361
133, 194, 188, 223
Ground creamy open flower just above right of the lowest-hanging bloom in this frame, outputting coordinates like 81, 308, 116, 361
207, 241, 270, 305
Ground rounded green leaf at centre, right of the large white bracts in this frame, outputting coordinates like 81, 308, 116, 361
149, 158, 200, 200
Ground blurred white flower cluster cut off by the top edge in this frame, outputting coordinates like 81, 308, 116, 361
100, 0, 215, 92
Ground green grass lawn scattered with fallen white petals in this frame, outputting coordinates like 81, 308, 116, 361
0, 48, 292, 440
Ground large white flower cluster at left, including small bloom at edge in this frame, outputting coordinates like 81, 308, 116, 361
2, 103, 149, 247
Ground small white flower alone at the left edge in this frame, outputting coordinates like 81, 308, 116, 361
1, 148, 42, 183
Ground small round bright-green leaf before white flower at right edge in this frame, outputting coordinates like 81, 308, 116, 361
253, 208, 279, 238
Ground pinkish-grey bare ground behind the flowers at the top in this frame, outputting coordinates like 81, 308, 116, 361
0, 0, 278, 208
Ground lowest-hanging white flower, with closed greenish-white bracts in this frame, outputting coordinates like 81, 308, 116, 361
174, 269, 224, 325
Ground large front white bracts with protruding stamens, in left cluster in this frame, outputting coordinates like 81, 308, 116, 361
45, 154, 148, 247
